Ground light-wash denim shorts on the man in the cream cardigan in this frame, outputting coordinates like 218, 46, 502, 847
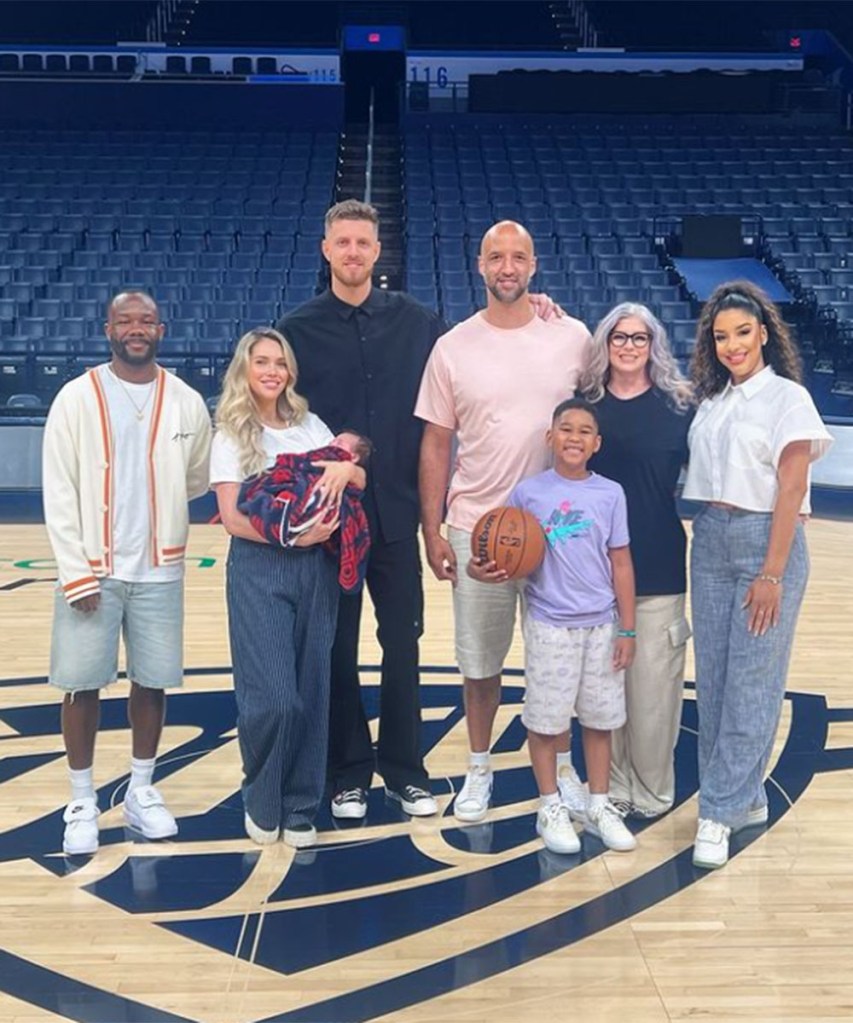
49, 578, 184, 693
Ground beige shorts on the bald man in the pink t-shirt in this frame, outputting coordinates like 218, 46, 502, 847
447, 526, 524, 678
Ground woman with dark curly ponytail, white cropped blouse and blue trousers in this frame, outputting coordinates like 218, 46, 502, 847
684, 280, 832, 869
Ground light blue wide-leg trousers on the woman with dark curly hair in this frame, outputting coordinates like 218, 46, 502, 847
690, 505, 809, 827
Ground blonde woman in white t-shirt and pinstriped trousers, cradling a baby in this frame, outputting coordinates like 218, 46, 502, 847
211, 328, 365, 848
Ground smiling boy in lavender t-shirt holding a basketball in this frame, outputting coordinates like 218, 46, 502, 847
469, 398, 636, 853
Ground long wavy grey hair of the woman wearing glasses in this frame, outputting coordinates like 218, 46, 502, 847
578, 302, 693, 411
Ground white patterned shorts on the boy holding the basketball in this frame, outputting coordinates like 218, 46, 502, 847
522, 615, 625, 736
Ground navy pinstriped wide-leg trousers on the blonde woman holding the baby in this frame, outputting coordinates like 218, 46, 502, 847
226, 537, 339, 831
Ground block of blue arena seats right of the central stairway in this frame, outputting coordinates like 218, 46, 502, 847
405, 117, 853, 357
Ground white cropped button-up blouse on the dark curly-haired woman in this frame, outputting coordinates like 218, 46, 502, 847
684, 366, 833, 515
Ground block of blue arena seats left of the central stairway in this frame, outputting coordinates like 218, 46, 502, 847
0, 131, 338, 404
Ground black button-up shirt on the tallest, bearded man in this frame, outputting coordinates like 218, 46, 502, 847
276, 287, 447, 543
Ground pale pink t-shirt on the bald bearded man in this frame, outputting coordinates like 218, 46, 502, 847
414, 313, 590, 532
